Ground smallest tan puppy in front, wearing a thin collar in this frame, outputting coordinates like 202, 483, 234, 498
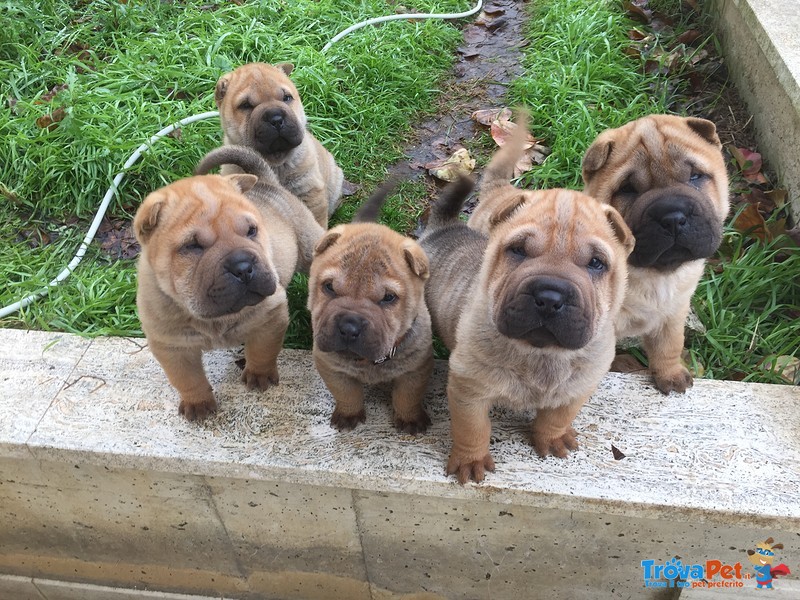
308, 182, 433, 434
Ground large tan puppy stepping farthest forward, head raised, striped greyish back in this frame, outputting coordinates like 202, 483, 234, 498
420, 164, 633, 483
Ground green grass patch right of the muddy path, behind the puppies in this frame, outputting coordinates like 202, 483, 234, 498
510, 0, 666, 189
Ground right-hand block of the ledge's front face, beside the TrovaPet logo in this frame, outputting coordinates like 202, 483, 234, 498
356, 492, 797, 600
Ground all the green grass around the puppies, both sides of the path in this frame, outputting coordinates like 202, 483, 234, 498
0, 0, 800, 382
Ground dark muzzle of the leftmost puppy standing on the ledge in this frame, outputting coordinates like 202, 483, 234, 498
204, 250, 278, 317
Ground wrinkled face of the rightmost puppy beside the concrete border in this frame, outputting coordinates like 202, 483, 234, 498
583, 115, 728, 271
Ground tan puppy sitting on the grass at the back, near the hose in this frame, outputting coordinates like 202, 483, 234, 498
214, 63, 344, 228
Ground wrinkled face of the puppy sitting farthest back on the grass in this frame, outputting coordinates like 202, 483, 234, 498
214, 63, 306, 159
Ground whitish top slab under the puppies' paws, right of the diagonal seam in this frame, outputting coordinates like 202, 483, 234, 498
15, 330, 800, 529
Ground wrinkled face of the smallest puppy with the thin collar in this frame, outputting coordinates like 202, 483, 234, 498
308, 223, 428, 362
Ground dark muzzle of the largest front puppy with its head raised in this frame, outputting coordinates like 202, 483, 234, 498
497, 276, 591, 350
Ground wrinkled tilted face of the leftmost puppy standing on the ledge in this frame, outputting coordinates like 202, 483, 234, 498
134, 175, 278, 319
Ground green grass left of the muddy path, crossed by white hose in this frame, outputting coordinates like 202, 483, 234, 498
0, 0, 468, 338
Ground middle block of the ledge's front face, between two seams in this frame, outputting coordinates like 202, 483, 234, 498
208, 478, 370, 600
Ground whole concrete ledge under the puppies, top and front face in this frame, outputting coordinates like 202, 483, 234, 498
0, 330, 800, 600
